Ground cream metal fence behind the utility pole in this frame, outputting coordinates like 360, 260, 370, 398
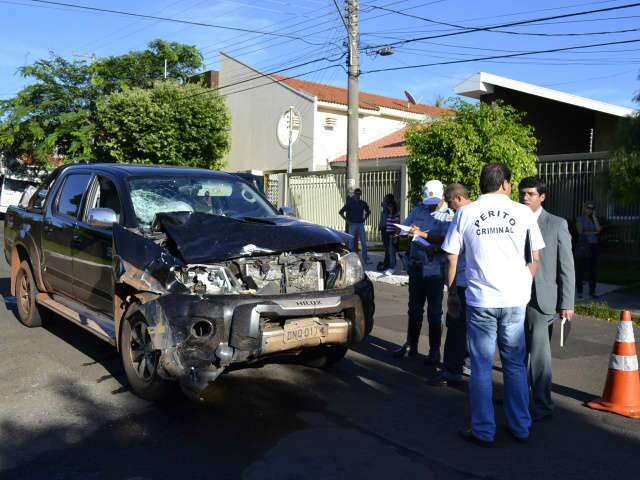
267, 170, 400, 242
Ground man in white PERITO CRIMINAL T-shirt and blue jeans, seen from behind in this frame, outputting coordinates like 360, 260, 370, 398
442, 163, 544, 447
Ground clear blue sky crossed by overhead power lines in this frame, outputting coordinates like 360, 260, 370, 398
0, 0, 640, 108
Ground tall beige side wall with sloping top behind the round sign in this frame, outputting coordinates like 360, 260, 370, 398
220, 54, 315, 172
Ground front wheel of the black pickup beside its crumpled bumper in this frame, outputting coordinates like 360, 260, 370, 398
120, 314, 177, 402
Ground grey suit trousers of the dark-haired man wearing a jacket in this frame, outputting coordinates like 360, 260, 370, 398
525, 297, 555, 418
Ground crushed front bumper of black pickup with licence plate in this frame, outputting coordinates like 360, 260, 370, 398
139, 278, 374, 389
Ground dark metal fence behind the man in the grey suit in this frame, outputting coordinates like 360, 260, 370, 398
538, 152, 640, 256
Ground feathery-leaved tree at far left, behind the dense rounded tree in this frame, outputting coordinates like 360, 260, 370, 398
0, 40, 202, 164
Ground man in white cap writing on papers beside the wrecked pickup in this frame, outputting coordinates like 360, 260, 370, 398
394, 180, 453, 365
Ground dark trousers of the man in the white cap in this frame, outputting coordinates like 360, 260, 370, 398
407, 263, 444, 355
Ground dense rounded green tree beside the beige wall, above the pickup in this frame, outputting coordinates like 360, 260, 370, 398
96, 82, 230, 169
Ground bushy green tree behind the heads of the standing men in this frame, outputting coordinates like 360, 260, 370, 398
405, 100, 536, 203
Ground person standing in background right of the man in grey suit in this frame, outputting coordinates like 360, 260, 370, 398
575, 202, 602, 298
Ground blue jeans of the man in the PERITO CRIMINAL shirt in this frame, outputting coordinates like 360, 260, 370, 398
467, 306, 531, 442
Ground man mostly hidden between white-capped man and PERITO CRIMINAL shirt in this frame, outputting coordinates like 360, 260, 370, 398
428, 183, 471, 387
